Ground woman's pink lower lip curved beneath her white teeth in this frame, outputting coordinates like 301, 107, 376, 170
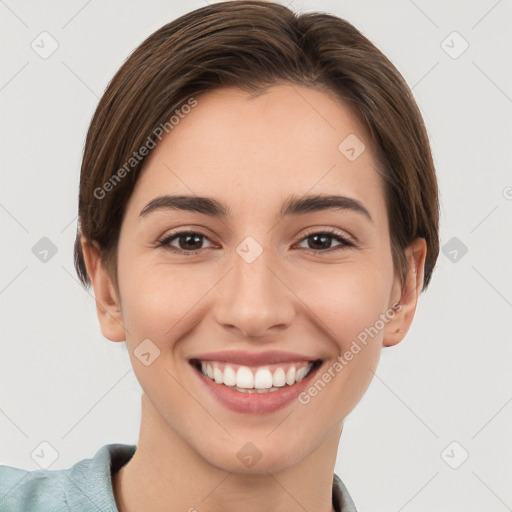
193, 365, 321, 414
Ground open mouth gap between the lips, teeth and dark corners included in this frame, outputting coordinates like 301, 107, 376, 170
190, 359, 322, 393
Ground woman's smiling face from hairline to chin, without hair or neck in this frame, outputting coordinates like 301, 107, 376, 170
89, 85, 424, 473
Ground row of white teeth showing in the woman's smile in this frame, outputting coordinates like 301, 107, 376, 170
196, 361, 313, 393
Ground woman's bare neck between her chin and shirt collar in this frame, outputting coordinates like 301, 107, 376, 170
113, 395, 342, 512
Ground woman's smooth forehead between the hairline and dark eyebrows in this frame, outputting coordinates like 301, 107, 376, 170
127, 85, 385, 224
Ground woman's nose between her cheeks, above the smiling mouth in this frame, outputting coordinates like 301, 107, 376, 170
215, 246, 296, 338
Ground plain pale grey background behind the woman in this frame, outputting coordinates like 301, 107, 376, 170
0, 0, 512, 512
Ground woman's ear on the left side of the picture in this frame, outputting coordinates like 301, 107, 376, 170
80, 237, 126, 341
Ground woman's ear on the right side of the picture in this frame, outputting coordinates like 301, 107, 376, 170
382, 238, 427, 347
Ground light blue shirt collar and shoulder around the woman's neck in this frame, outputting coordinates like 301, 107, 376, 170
0, 443, 356, 512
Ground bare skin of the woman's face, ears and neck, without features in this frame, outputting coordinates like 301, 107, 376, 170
82, 85, 426, 512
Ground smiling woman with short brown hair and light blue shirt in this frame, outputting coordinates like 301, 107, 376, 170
0, 1, 439, 512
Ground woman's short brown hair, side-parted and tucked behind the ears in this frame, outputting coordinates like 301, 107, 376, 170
75, 0, 439, 289
